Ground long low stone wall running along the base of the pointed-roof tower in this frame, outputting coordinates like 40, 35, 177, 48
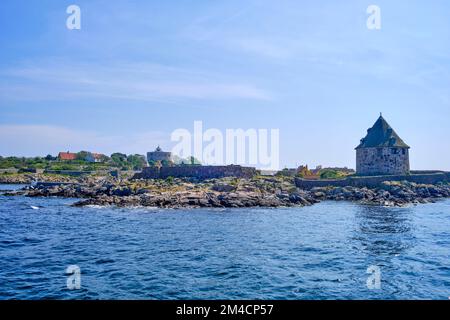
295, 172, 450, 190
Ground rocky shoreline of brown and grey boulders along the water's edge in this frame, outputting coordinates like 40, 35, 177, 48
3, 177, 450, 208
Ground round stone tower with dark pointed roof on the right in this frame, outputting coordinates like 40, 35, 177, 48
356, 115, 409, 175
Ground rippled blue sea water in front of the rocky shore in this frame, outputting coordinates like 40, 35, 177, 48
0, 185, 450, 300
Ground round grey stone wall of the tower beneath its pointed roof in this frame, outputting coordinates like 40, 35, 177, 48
356, 147, 409, 175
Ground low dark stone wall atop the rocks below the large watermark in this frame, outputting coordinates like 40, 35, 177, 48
133, 165, 257, 179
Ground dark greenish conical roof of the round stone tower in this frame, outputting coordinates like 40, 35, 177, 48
356, 115, 409, 149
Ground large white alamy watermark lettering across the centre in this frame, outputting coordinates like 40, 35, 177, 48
171, 121, 280, 170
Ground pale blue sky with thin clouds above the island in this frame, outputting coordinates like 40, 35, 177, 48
0, 0, 450, 170
